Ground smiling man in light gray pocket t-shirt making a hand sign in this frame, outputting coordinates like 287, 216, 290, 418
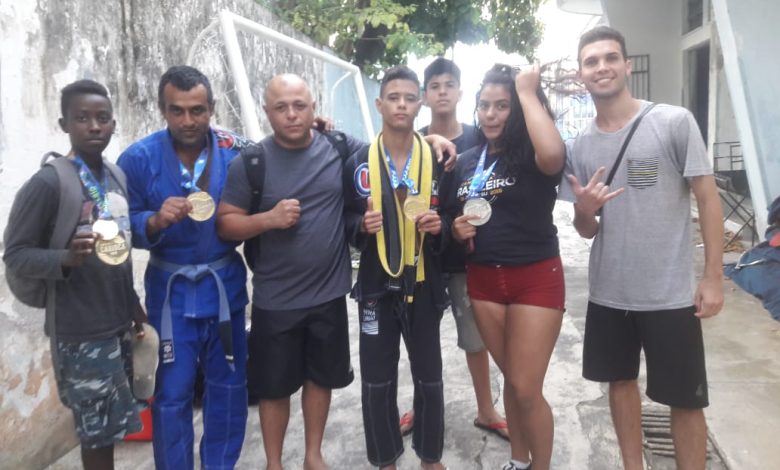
559, 26, 723, 469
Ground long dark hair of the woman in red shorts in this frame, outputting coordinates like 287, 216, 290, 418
474, 64, 555, 174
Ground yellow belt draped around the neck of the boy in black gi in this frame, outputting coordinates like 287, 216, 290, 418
368, 133, 433, 302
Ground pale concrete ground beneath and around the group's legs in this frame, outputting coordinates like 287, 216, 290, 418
49, 203, 780, 470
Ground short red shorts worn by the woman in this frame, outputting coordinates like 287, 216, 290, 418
466, 256, 566, 311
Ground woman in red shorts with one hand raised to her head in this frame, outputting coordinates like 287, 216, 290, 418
442, 65, 564, 470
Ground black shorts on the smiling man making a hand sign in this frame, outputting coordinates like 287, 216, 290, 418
582, 302, 709, 408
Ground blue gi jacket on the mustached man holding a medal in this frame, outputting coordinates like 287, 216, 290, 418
117, 128, 249, 318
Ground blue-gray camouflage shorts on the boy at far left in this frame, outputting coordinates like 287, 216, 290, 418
57, 336, 141, 449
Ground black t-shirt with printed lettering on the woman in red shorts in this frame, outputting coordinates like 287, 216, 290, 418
442, 147, 561, 266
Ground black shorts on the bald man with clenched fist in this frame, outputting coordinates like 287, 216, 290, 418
247, 297, 355, 400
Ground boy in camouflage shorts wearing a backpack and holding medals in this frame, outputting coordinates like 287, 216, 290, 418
3, 80, 146, 470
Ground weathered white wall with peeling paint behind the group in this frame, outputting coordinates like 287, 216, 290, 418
0, 0, 328, 469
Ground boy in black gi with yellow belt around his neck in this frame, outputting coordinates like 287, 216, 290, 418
344, 66, 449, 470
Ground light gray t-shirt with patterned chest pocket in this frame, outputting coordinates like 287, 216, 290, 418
559, 101, 712, 311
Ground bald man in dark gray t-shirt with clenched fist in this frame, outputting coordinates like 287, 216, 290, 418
217, 74, 364, 469
